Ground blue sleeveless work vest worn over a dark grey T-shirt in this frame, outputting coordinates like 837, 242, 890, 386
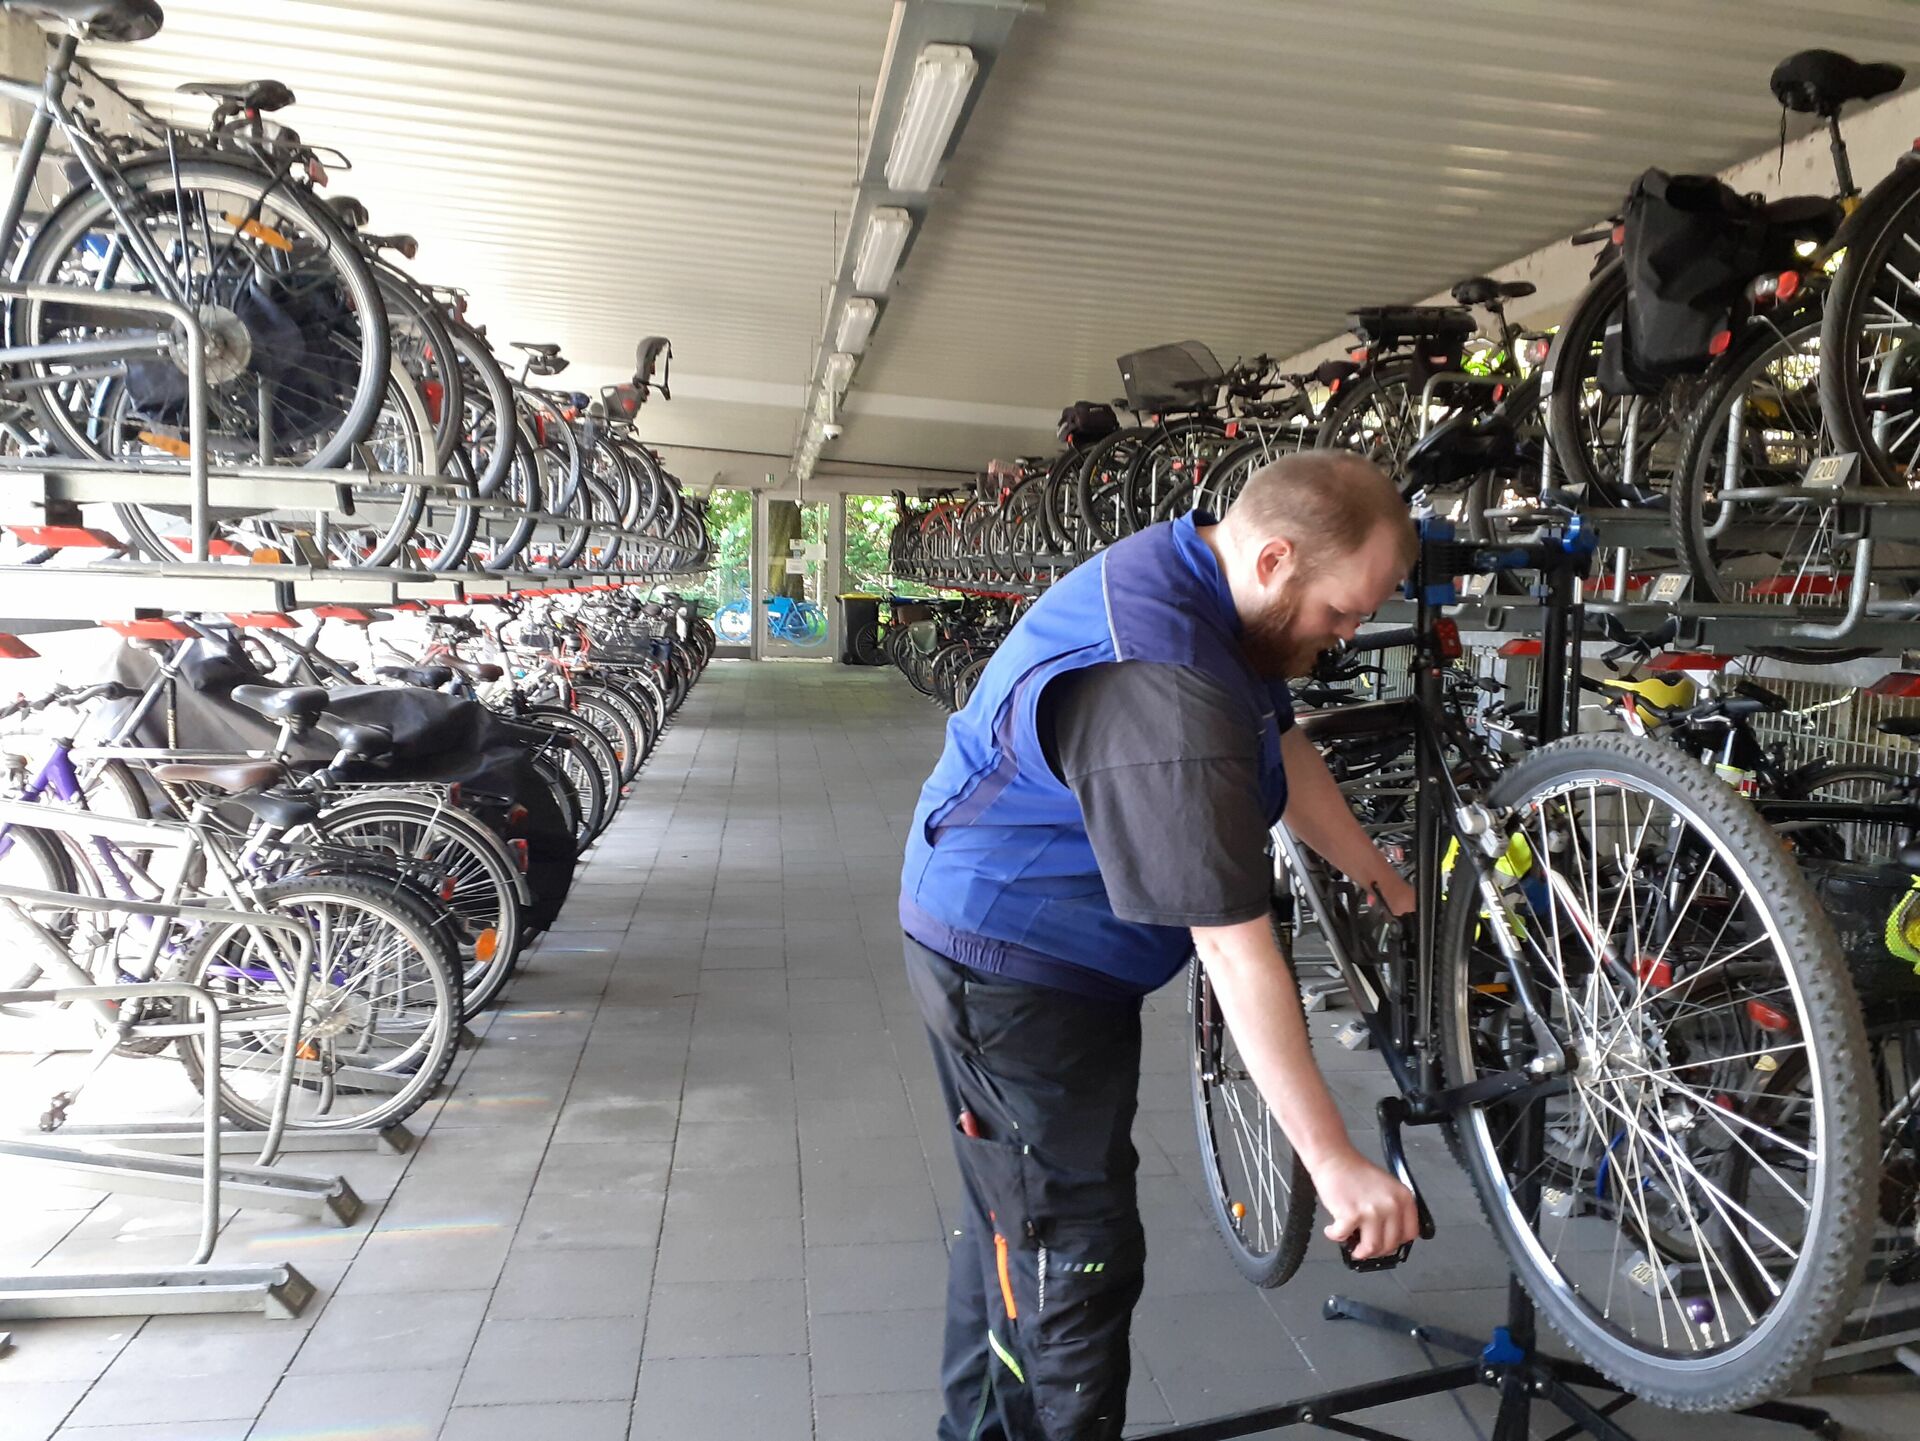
900, 514, 1292, 996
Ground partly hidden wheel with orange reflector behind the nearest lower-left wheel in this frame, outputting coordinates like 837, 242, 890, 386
312, 796, 524, 1019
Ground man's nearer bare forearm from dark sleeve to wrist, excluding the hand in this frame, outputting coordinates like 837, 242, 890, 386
1194, 917, 1354, 1170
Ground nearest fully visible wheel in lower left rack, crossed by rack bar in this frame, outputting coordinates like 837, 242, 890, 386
180, 877, 461, 1130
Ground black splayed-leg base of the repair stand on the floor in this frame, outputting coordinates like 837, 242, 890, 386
1140, 1295, 1839, 1441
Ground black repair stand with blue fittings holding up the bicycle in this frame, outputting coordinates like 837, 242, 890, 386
1140, 516, 1839, 1441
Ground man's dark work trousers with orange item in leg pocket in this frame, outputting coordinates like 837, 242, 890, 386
906, 940, 1146, 1441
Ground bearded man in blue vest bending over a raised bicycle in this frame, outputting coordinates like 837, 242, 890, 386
900, 451, 1417, 1441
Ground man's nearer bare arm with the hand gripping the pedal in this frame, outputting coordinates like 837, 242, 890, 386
1192, 917, 1419, 1261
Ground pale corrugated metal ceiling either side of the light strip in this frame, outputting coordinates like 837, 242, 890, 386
78, 0, 1920, 468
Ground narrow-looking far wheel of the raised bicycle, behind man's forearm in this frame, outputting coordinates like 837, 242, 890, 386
1187, 956, 1315, 1287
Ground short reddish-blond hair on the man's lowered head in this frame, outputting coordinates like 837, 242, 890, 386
1223, 451, 1419, 570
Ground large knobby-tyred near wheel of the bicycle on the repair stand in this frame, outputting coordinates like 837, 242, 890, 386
1438, 737, 1876, 1410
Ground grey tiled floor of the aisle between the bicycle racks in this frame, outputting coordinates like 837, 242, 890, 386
0, 664, 1920, 1441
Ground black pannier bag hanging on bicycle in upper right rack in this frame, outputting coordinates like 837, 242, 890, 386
1620, 171, 1766, 374
